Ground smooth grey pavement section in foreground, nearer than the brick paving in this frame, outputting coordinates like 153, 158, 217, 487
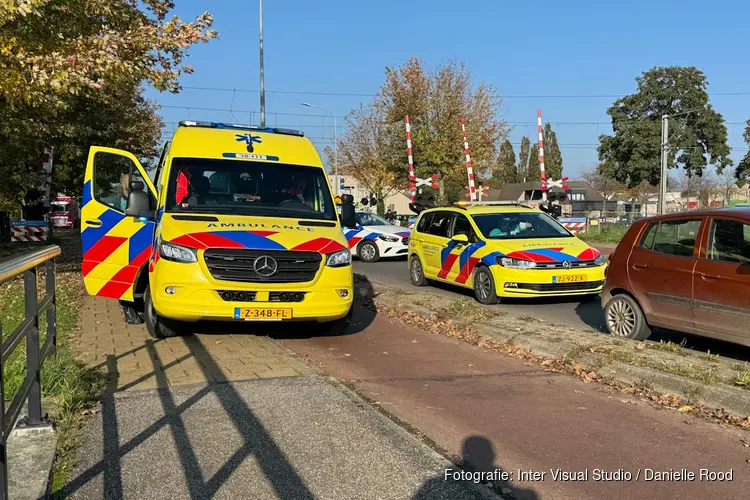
63, 376, 481, 500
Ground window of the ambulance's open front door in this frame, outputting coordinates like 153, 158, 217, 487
93, 151, 156, 212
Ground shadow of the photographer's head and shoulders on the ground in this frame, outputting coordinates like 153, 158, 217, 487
412, 436, 539, 500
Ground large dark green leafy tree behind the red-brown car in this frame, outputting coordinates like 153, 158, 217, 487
599, 66, 732, 186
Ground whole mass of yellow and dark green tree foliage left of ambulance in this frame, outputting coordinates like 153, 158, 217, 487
0, 0, 216, 208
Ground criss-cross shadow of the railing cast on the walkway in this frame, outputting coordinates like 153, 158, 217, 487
53, 336, 313, 500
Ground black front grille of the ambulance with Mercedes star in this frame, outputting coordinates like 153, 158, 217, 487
203, 248, 322, 283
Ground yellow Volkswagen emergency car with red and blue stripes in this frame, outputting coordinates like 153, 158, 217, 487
409, 202, 607, 304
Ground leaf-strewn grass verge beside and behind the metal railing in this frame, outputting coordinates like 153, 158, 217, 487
0, 239, 105, 492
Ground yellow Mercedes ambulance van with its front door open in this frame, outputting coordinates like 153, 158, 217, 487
81, 121, 356, 337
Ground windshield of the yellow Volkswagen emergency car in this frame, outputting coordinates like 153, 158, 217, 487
474, 212, 573, 240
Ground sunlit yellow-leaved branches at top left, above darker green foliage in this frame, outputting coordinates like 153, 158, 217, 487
0, 0, 217, 106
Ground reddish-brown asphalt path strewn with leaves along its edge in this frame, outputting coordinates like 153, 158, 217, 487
281, 311, 750, 500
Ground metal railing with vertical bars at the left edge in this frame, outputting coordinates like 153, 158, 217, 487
0, 245, 61, 500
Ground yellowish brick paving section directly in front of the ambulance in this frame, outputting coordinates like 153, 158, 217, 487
73, 296, 315, 391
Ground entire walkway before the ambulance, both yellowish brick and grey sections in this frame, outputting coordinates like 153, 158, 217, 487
64, 297, 488, 500
